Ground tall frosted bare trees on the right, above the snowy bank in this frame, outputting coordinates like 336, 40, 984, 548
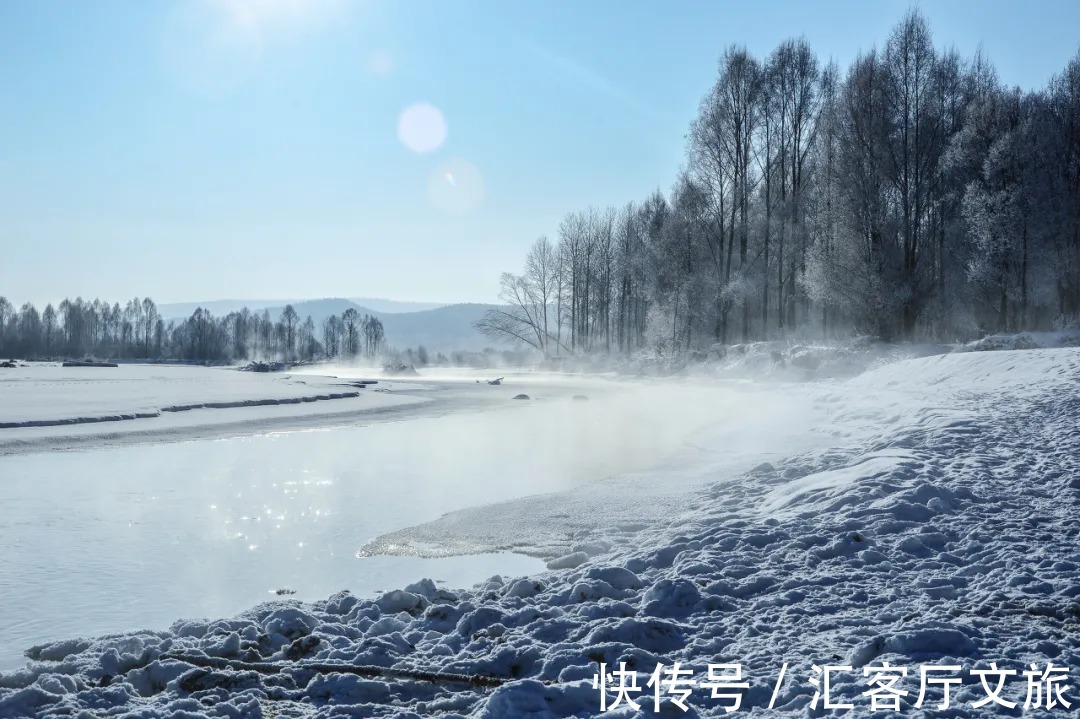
477, 12, 1080, 354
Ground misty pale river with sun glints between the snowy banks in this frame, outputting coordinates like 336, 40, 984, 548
0, 369, 751, 668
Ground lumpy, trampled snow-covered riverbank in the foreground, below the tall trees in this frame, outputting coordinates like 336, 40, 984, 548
0, 349, 1080, 719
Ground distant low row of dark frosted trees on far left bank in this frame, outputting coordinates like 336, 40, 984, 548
0, 297, 386, 362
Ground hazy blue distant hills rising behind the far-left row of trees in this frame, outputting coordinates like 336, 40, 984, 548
158, 297, 498, 352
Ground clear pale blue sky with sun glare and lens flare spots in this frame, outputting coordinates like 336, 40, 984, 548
0, 0, 1080, 308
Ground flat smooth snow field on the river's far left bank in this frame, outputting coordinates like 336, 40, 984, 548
0, 363, 583, 456
